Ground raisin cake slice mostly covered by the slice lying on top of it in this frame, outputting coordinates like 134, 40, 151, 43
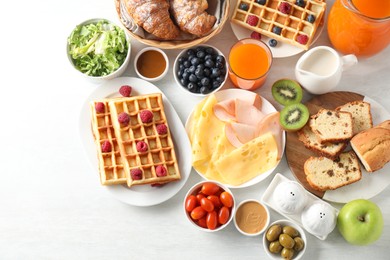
297, 124, 347, 160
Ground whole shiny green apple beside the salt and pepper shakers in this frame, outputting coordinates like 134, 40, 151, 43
337, 199, 383, 245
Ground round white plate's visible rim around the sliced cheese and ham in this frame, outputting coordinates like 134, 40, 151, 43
185, 89, 286, 188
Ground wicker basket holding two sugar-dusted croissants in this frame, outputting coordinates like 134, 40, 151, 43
115, 0, 230, 49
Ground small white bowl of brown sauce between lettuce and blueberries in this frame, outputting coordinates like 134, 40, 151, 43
134, 47, 169, 81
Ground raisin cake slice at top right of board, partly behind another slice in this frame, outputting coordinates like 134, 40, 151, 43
336, 100, 372, 135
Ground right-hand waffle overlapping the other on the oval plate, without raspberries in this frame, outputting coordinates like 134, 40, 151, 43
109, 93, 181, 187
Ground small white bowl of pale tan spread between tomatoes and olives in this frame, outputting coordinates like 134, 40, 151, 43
234, 199, 270, 237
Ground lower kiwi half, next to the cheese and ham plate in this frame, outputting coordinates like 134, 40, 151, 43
279, 103, 310, 131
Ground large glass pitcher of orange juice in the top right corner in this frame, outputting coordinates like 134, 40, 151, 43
328, 0, 390, 57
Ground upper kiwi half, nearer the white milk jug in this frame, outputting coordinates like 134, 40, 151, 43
272, 79, 303, 106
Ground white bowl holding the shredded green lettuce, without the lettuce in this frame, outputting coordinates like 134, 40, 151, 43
66, 18, 131, 83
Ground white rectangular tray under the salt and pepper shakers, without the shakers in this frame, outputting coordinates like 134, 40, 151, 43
261, 173, 339, 240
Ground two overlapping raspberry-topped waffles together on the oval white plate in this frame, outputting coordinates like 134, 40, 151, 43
90, 93, 181, 187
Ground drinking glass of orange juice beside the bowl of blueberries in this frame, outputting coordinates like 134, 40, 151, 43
229, 38, 272, 90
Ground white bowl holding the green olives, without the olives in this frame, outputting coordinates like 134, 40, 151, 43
263, 219, 307, 260
